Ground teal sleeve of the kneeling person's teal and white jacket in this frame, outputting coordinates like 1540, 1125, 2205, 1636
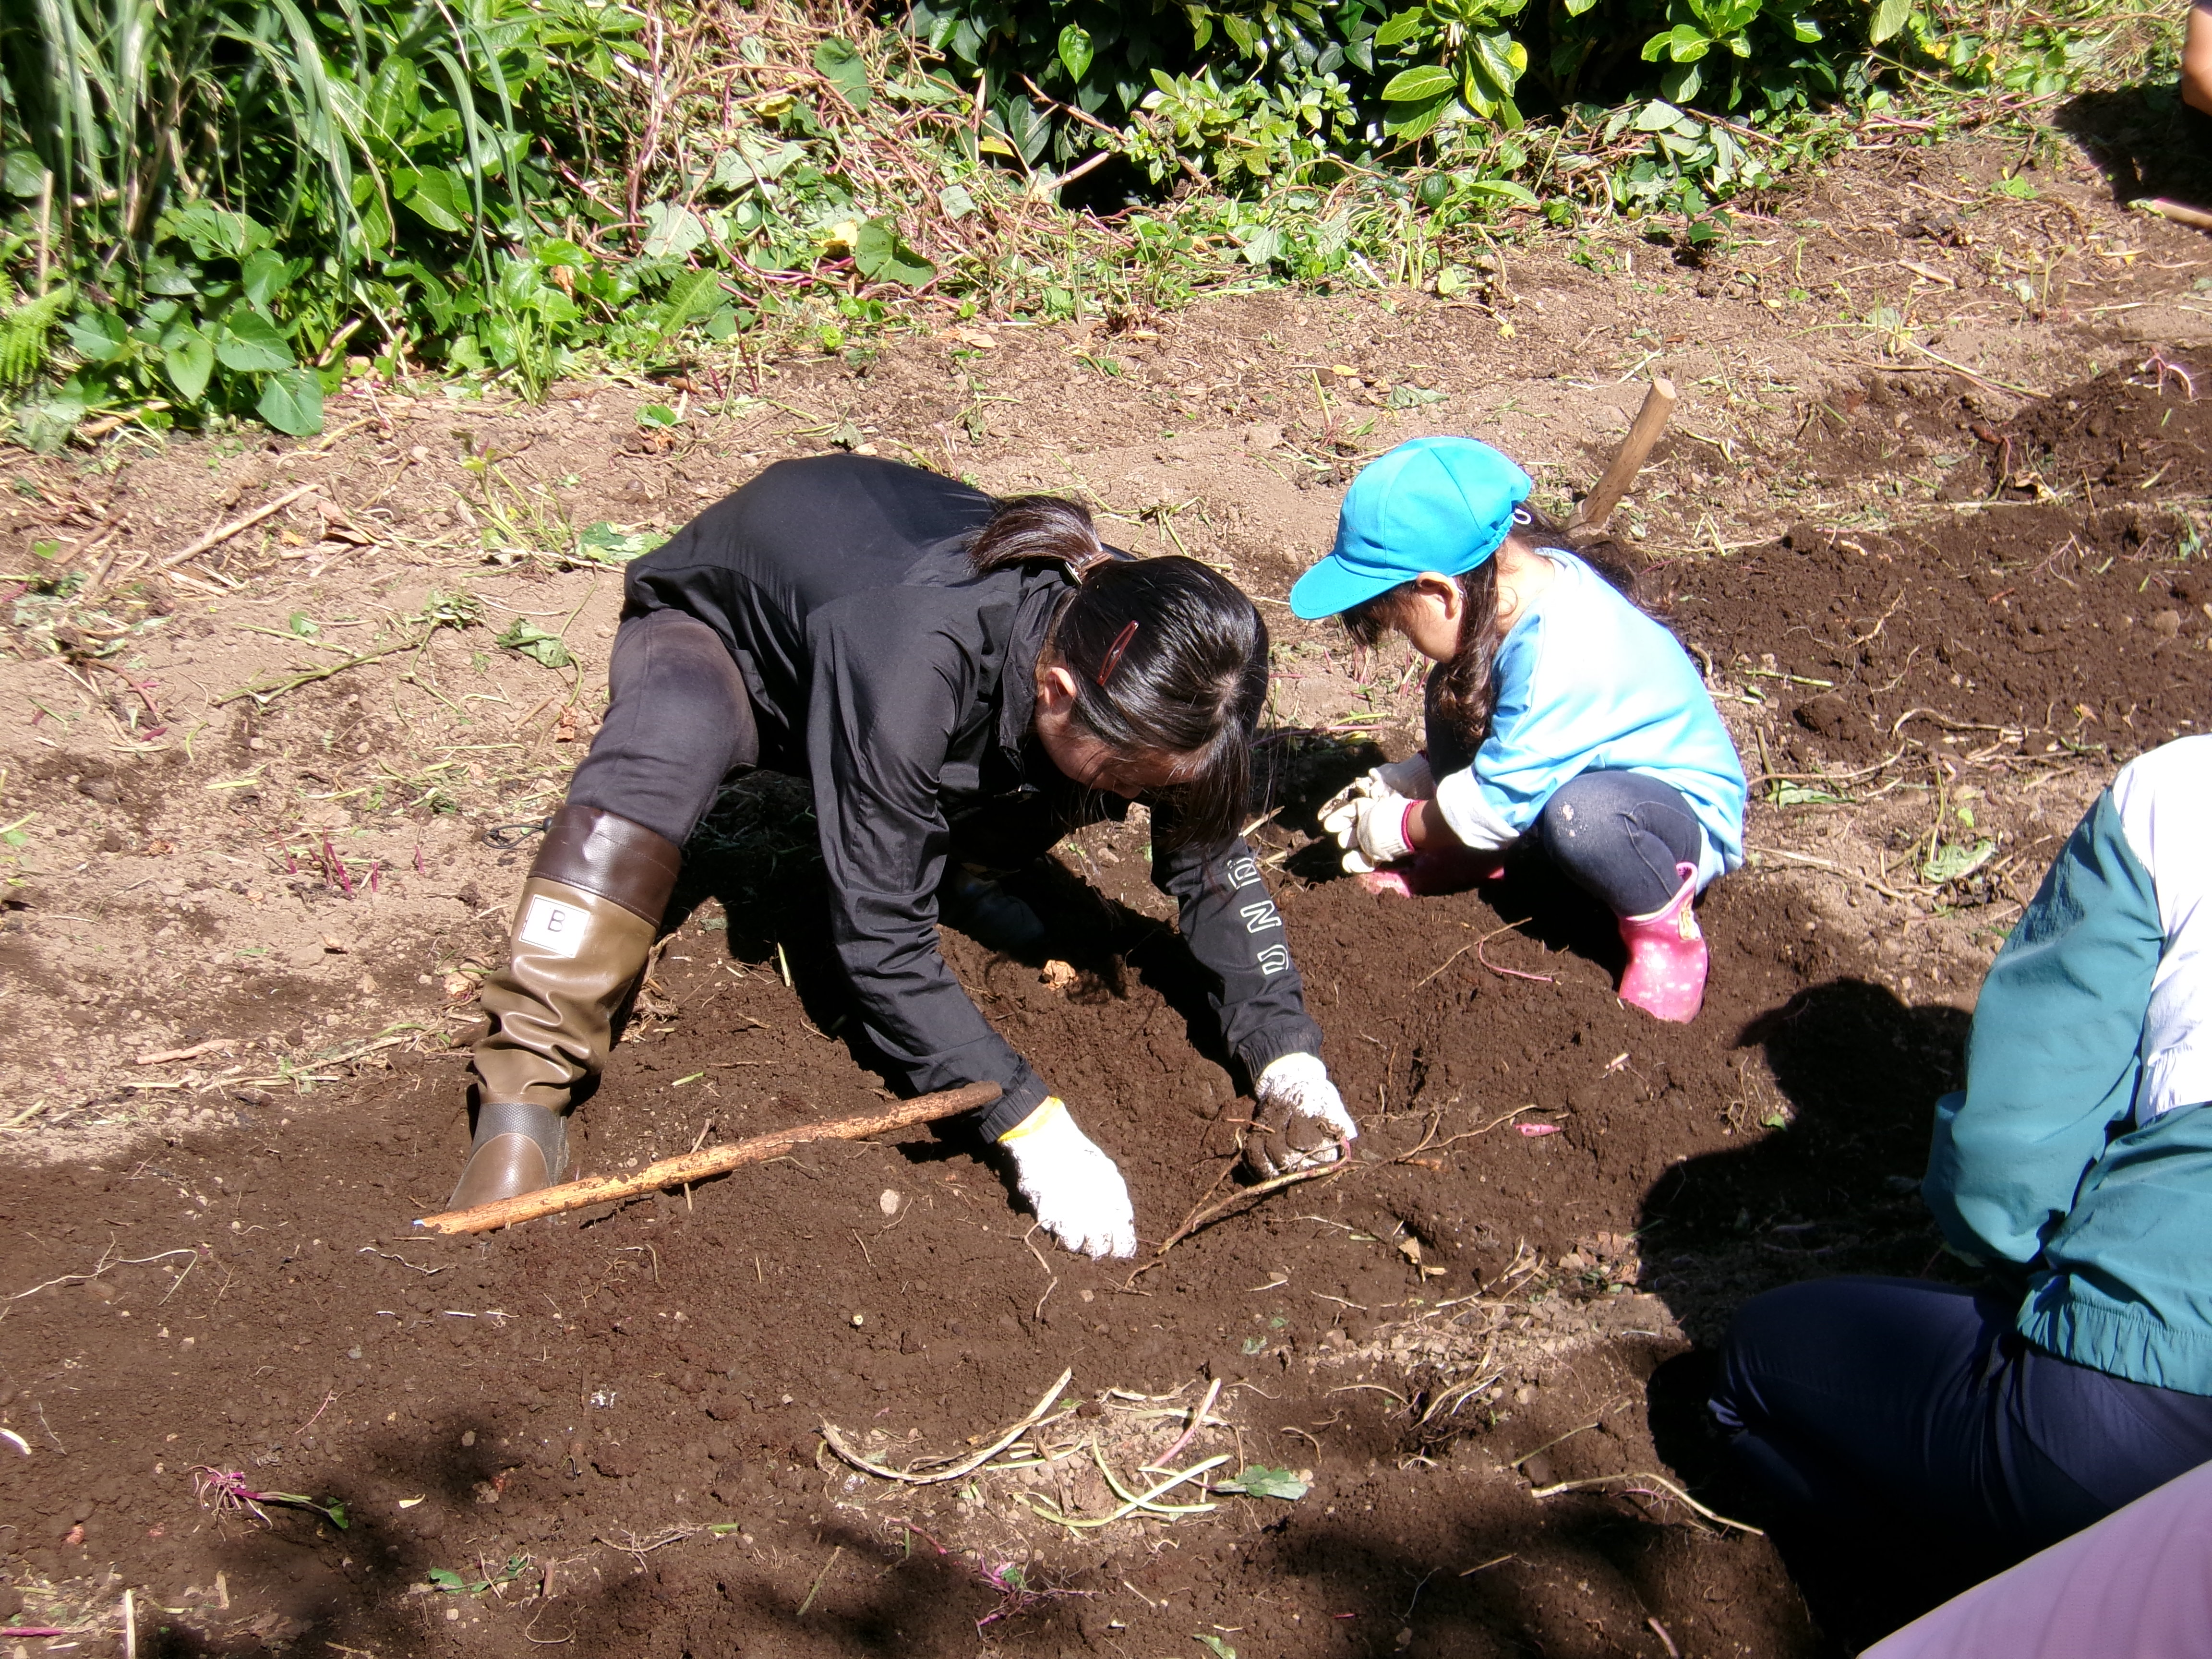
1920, 790, 2164, 1265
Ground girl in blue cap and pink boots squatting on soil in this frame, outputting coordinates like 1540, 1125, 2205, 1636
1289, 438, 1745, 1022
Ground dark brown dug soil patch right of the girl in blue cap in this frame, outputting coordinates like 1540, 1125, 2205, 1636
1652, 358, 2212, 772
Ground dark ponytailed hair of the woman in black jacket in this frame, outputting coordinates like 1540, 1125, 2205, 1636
969, 495, 1267, 847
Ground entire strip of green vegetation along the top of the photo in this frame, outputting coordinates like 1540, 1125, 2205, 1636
0, 0, 2167, 447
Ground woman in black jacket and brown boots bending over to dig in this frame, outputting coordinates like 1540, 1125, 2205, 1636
454, 456, 1358, 1256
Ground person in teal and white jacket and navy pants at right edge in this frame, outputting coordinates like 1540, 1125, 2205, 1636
1712, 736, 2212, 1560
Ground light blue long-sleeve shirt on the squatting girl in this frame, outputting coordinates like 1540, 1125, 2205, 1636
1436, 549, 1745, 887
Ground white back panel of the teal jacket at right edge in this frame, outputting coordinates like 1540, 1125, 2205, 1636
2113, 736, 2212, 1124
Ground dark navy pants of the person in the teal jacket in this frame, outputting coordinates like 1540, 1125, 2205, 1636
1712, 1278, 2212, 1560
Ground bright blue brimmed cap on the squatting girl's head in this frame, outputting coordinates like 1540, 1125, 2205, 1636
1289, 438, 1531, 622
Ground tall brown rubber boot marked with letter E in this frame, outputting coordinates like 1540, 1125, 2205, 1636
447, 805, 681, 1210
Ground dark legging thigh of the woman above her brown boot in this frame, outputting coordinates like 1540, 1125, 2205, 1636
568, 611, 761, 847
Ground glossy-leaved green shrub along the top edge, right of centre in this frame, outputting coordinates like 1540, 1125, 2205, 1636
909, 0, 2026, 192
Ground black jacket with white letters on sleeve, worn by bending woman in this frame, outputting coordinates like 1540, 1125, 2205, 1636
626, 456, 1321, 1135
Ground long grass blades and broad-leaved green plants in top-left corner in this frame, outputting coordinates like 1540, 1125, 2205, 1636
0, 0, 644, 440
